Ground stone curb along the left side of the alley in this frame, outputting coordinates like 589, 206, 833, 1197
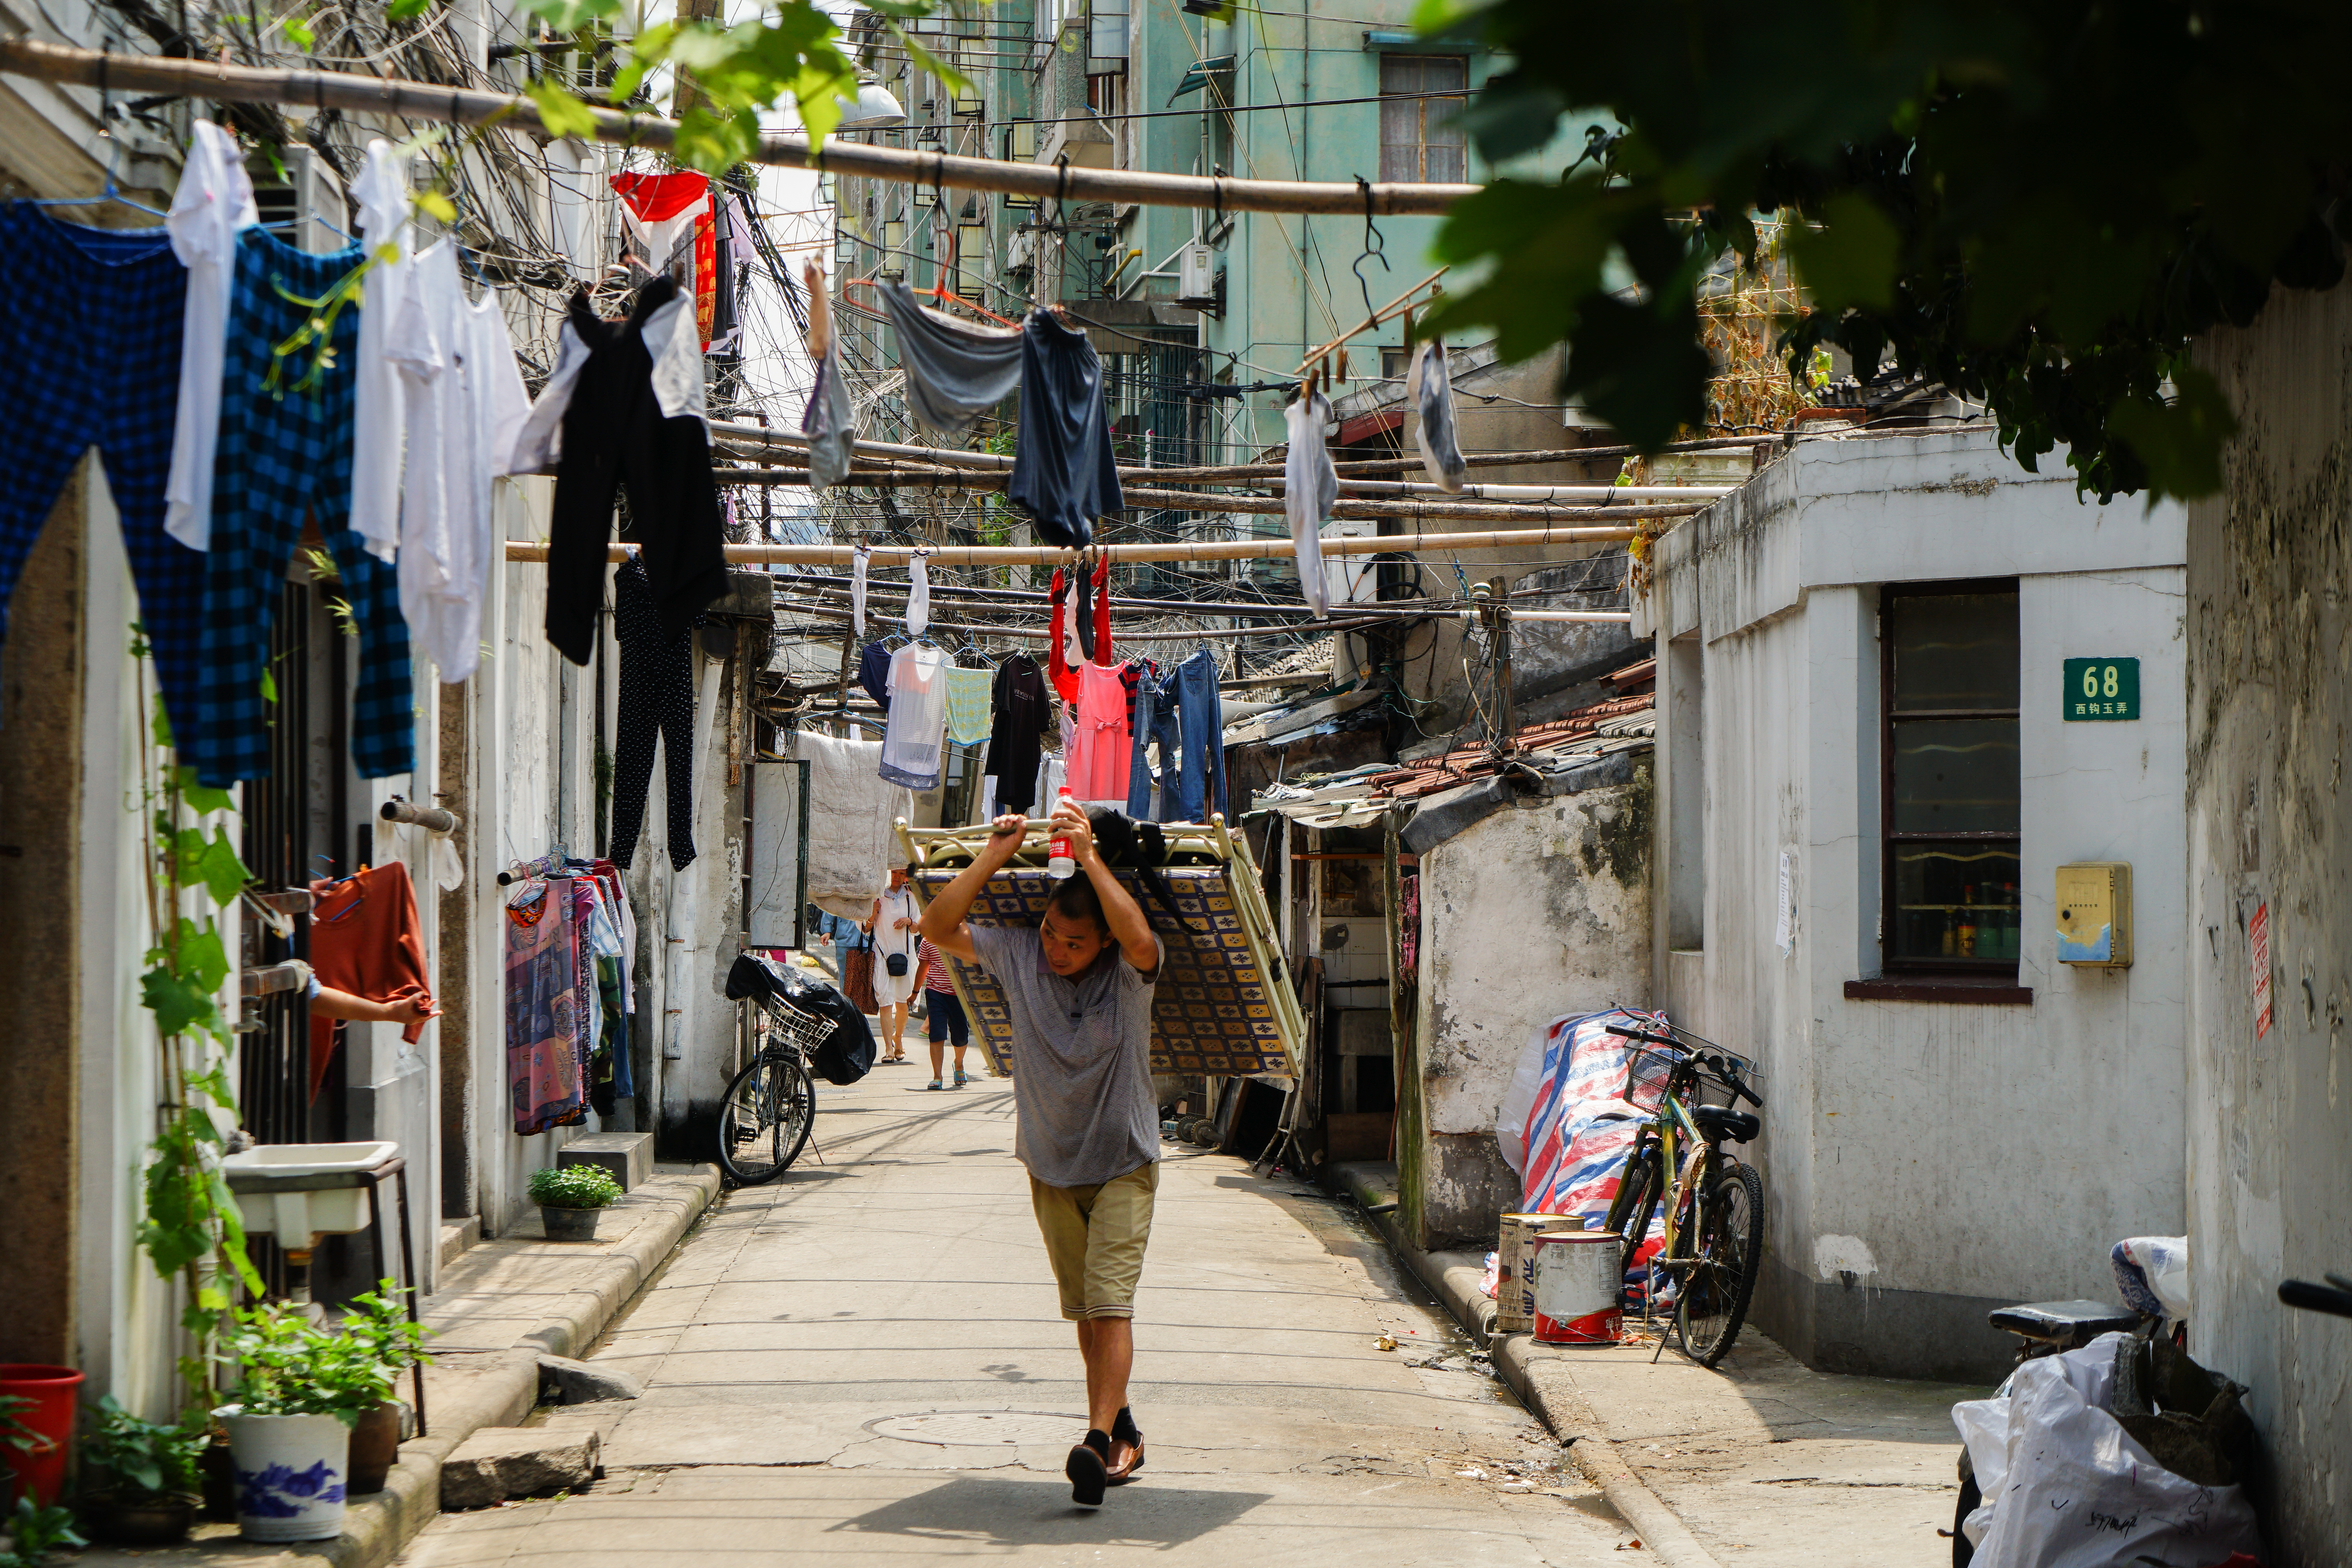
232, 1166, 720, 1568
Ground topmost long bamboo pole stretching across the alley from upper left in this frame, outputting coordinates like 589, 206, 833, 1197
0, 38, 1479, 219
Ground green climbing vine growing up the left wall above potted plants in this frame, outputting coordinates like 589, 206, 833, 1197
132, 623, 261, 1401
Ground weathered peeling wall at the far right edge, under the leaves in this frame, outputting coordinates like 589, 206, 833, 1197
2187, 278, 2352, 1566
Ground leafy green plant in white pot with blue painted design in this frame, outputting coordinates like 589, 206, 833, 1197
214, 1302, 393, 1540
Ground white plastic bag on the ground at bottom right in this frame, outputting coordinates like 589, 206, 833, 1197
1952, 1333, 2263, 1568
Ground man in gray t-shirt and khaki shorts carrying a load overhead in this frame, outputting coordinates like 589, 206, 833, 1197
922, 799, 1162, 1507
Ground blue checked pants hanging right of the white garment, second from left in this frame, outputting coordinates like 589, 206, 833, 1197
195, 228, 416, 788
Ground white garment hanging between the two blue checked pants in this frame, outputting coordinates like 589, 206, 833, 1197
162, 120, 261, 550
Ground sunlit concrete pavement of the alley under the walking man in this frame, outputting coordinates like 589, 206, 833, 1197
405, 1062, 1632, 1568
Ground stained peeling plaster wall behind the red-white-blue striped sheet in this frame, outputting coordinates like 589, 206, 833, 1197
1418, 757, 1651, 1246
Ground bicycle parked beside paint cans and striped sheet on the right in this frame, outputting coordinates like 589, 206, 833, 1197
1604, 1023, 1764, 1366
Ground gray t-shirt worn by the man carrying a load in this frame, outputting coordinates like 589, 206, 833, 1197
971, 926, 1167, 1187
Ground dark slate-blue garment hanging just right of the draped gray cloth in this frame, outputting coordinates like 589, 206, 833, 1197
1007, 310, 1127, 550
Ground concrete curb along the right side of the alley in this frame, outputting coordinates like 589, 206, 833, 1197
1331, 1161, 1722, 1568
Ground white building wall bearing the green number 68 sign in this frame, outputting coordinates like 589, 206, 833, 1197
1637, 430, 2187, 1375
